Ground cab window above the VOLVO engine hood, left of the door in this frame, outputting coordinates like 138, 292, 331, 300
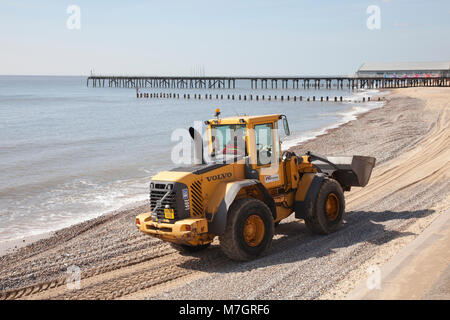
211, 124, 247, 158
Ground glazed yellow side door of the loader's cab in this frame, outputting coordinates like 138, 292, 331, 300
249, 121, 284, 189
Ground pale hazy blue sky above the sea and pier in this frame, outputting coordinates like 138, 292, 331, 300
0, 0, 450, 75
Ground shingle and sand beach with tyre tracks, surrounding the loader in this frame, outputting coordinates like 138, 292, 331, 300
0, 88, 450, 299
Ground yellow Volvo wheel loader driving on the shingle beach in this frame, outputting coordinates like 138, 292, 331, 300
136, 109, 375, 261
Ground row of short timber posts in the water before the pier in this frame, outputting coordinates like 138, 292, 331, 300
136, 92, 384, 102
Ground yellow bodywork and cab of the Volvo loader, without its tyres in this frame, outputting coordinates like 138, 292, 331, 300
136, 114, 374, 246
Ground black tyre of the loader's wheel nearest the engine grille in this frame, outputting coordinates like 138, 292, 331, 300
219, 198, 274, 261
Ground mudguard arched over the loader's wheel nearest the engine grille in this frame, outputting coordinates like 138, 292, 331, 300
207, 179, 276, 235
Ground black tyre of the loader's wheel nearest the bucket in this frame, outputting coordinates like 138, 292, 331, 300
305, 178, 345, 234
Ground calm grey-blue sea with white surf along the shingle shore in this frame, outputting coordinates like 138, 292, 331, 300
0, 76, 376, 242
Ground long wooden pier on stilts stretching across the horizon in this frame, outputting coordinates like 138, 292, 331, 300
86, 75, 450, 89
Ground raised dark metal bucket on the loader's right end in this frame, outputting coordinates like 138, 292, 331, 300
311, 154, 375, 187
